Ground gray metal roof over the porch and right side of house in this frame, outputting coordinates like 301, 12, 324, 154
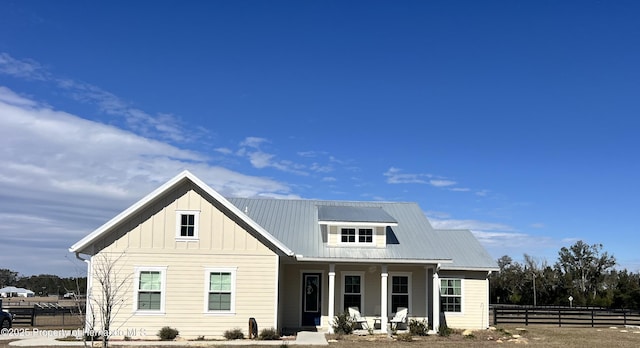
228, 198, 497, 269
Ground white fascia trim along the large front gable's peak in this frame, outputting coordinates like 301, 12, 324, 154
69, 170, 294, 256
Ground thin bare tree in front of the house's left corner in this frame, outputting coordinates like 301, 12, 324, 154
87, 252, 131, 348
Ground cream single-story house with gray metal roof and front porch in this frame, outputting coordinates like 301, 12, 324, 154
69, 171, 498, 338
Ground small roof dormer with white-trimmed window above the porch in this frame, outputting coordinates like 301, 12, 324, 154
318, 206, 398, 248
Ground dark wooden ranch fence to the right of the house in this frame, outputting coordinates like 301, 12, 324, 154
492, 306, 640, 327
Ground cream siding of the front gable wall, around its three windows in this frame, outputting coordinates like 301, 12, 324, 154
92, 184, 279, 338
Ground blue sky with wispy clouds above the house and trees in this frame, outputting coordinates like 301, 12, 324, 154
0, 1, 640, 276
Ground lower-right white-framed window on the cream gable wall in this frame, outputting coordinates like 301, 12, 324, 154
205, 268, 236, 313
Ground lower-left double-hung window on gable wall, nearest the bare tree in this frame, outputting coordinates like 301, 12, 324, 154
134, 267, 166, 314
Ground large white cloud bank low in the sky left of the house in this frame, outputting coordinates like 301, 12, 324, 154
0, 86, 297, 274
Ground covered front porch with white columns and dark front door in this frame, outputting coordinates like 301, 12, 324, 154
278, 262, 440, 332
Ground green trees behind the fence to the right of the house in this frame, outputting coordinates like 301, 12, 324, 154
489, 241, 640, 309
